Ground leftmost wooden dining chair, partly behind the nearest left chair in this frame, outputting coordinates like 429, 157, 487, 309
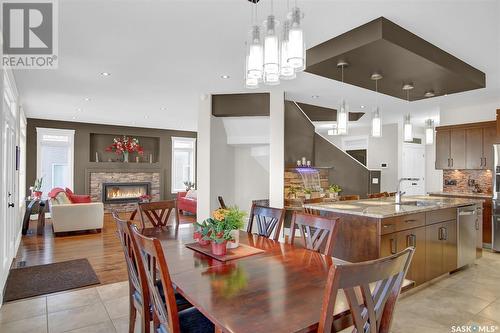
111, 210, 151, 333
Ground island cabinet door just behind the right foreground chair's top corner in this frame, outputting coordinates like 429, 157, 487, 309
397, 227, 426, 285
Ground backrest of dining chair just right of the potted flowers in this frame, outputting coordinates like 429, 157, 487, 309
247, 204, 285, 240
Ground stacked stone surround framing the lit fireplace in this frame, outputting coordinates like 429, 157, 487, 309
87, 170, 162, 212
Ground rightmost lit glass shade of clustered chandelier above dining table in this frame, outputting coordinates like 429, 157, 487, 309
288, 7, 306, 72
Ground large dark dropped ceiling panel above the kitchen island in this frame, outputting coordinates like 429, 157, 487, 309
306, 17, 486, 101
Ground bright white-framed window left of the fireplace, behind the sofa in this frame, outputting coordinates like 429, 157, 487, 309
36, 128, 75, 194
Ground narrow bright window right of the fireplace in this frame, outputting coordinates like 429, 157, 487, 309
172, 137, 196, 193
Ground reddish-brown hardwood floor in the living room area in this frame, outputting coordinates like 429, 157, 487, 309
12, 213, 195, 284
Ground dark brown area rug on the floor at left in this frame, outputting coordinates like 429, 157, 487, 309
3, 259, 99, 302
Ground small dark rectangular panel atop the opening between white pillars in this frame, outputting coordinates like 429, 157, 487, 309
212, 93, 269, 117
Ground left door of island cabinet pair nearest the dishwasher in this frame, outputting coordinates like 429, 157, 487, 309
425, 223, 444, 281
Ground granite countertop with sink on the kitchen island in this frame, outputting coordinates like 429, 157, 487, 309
304, 195, 483, 218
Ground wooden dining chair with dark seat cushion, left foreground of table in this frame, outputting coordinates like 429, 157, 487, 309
130, 225, 214, 333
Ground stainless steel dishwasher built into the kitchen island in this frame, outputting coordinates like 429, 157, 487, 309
457, 205, 477, 267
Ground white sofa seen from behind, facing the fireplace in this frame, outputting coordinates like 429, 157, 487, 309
49, 200, 104, 233
